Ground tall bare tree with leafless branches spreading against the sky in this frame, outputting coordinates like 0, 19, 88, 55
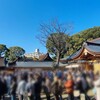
37, 20, 72, 66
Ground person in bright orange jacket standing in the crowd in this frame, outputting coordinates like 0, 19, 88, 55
64, 73, 74, 100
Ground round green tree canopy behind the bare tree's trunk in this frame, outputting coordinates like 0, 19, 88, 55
46, 33, 68, 57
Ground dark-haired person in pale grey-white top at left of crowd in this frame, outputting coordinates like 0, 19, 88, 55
17, 73, 27, 100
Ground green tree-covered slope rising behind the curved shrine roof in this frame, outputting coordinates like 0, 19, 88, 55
67, 27, 100, 55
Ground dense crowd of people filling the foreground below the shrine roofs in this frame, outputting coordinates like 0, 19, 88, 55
0, 68, 100, 100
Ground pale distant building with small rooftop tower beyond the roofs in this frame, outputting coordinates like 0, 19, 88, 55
25, 49, 44, 59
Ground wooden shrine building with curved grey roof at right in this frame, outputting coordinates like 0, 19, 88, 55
67, 38, 100, 72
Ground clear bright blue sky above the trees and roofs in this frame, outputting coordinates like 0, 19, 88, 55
0, 0, 100, 53
